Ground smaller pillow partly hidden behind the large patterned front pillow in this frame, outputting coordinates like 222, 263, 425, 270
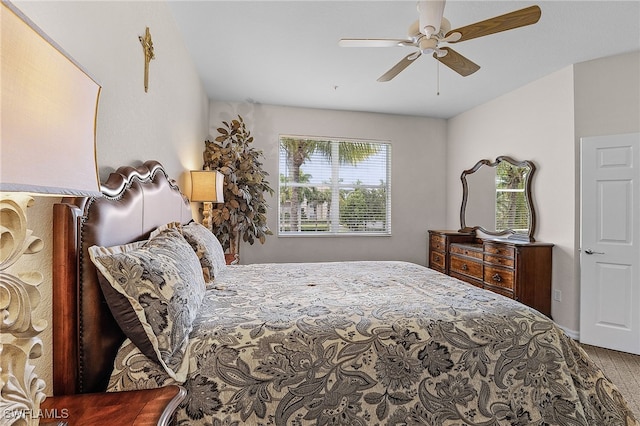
151, 221, 227, 284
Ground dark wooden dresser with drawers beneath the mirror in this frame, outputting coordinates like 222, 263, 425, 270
428, 230, 553, 317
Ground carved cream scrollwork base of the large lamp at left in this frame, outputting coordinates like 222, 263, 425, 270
0, 193, 47, 425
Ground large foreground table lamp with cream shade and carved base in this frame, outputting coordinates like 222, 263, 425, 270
0, 1, 100, 425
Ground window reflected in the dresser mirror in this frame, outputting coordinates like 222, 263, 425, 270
496, 161, 531, 233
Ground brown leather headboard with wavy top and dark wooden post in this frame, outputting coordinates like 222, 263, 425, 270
53, 161, 192, 395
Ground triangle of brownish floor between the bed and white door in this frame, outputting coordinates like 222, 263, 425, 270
581, 344, 640, 419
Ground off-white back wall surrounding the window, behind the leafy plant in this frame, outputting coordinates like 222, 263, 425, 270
209, 102, 446, 265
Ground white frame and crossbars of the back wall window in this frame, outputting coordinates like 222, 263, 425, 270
277, 134, 392, 238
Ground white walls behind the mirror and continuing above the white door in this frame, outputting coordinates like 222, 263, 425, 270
447, 52, 640, 337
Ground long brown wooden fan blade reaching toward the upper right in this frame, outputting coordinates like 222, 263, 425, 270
446, 6, 542, 43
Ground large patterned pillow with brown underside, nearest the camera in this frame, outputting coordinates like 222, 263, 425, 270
89, 229, 205, 382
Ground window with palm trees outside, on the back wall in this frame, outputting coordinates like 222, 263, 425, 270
279, 136, 391, 235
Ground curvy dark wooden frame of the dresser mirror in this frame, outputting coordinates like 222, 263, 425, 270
460, 155, 536, 242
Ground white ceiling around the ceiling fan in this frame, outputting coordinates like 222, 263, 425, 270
169, 0, 640, 118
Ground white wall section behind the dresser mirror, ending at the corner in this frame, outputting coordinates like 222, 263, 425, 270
447, 67, 579, 331
